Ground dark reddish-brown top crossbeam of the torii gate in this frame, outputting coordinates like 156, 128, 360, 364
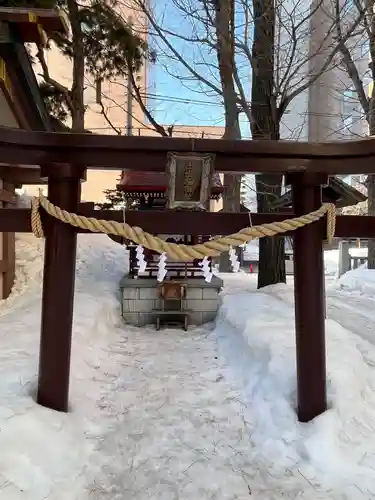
0, 128, 375, 175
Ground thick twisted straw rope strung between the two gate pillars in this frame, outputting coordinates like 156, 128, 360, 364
31, 192, 336, 262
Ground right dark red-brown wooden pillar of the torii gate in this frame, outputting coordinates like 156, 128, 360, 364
287, 174, 328, 422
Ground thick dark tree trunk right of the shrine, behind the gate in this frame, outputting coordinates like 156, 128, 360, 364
251, 0, 286, 288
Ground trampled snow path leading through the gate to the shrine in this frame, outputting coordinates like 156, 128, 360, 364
88, 322, 267, 500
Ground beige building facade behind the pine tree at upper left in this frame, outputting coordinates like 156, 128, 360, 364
27, 3, 223, 203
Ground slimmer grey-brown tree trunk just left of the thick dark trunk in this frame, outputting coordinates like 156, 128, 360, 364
215, 0, 242, 272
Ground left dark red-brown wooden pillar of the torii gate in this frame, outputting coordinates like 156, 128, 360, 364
37, 165, 84, 412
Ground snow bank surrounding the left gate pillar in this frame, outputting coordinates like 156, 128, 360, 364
0, 234, 125, 500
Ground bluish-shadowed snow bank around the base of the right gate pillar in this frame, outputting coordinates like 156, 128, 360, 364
217, 285, 375, 498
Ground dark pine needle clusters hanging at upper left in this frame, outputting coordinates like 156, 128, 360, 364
0, 0, 155, 129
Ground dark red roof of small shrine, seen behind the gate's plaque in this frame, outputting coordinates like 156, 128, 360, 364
117, 170, 224, 193
